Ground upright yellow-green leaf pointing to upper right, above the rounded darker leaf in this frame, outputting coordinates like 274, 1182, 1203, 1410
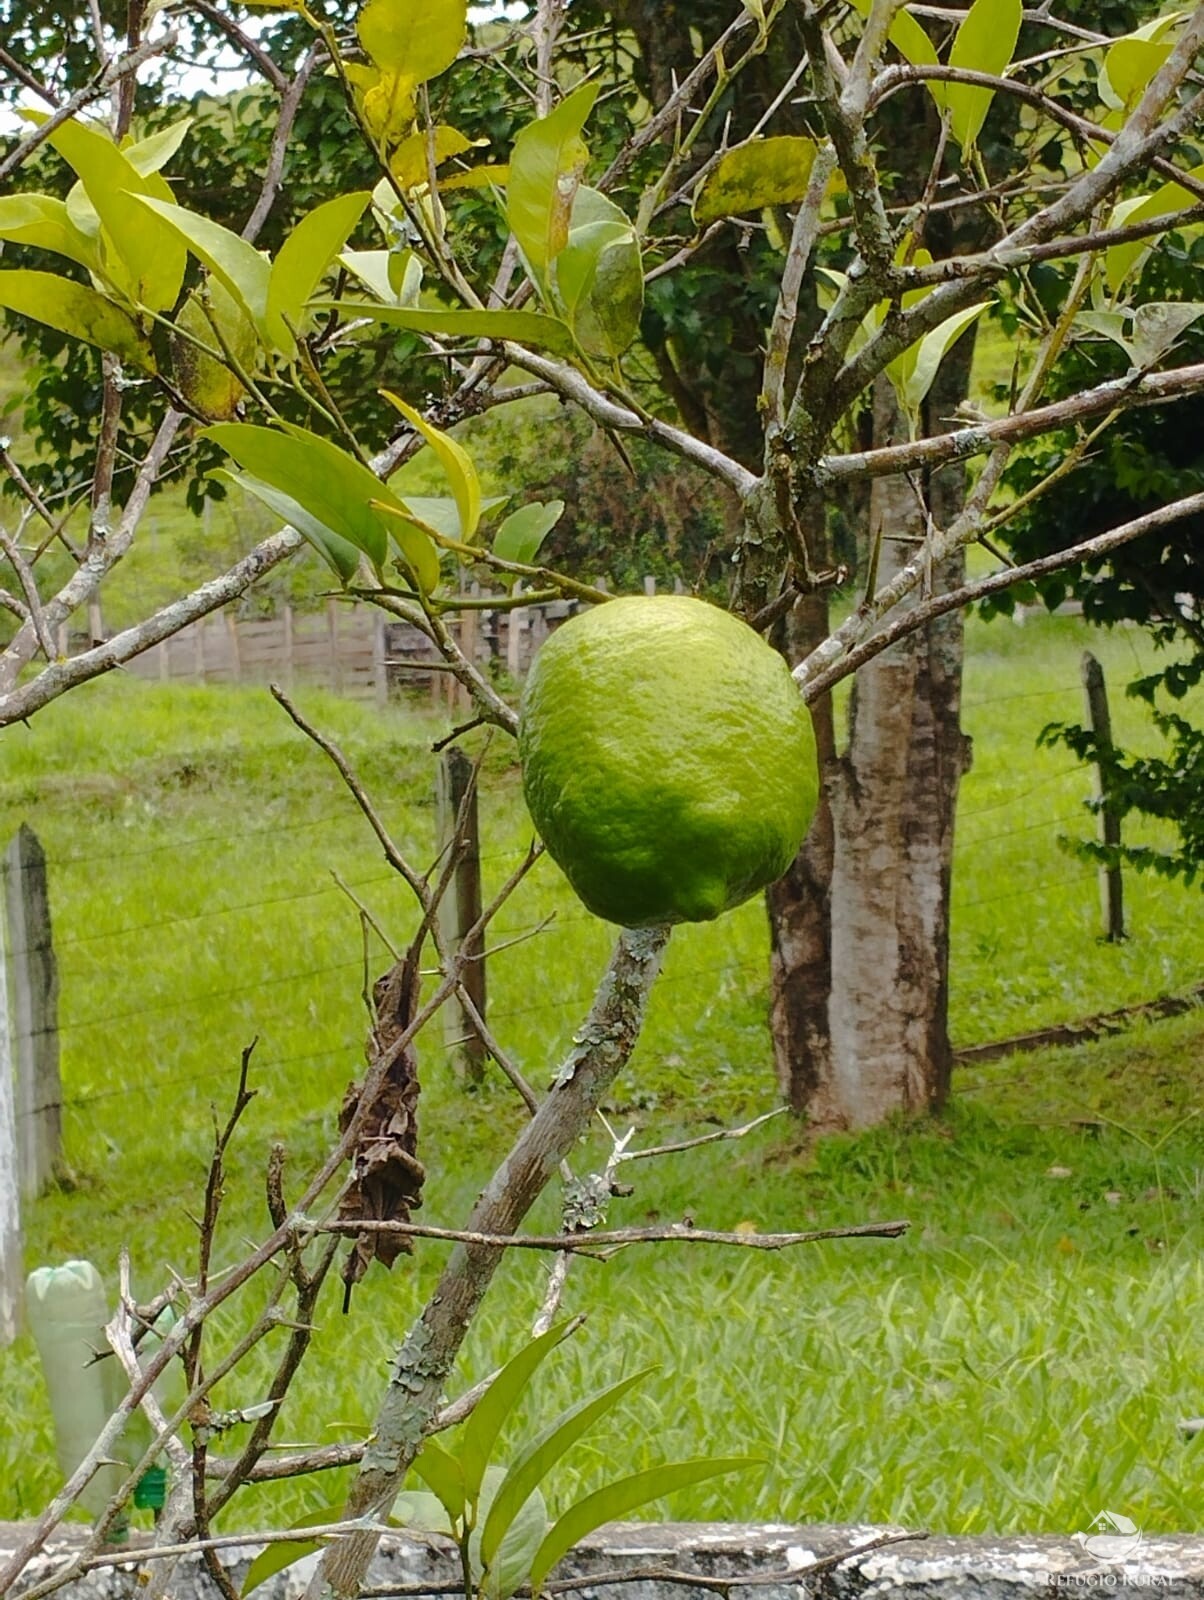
506, 83, 599, 290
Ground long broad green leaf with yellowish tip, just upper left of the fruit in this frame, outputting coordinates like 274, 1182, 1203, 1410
202, 422, 439, 590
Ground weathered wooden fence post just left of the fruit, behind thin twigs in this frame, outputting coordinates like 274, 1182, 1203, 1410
435, 744, 485, 1088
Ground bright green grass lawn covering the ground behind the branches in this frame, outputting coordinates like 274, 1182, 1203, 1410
0, 604, 1204, 1531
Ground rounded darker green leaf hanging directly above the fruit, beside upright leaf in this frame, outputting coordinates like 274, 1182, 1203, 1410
556, 186, 644, 360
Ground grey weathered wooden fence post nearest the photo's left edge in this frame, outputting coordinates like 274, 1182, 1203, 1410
3, 822, 62, 1195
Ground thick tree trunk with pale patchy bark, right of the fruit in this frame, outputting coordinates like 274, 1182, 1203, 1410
769, 358, 970, 1130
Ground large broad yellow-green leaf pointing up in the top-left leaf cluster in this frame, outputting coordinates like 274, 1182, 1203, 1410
37, 120, 186, 310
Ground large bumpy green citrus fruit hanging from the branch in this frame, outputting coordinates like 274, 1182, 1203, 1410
519, 595, 817, 928
